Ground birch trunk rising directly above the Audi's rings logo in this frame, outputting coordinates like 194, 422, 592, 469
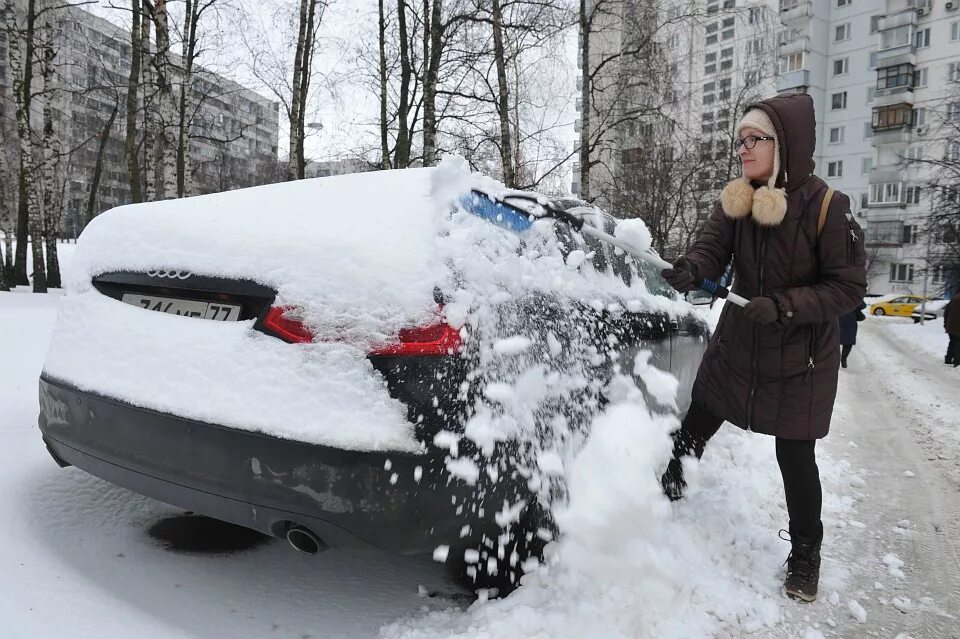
153, 0, 177, 200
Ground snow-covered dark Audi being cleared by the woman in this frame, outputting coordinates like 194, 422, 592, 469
39, 162, 707, 592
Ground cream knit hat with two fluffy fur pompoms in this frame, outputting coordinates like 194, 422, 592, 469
720, 108, 787, 226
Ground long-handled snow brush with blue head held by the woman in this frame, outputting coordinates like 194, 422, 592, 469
461, 190, 749, 306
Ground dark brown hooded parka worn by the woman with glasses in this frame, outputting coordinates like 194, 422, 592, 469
687, 94, 866, 439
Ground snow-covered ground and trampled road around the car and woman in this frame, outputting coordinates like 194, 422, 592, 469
0, 249, 960, 639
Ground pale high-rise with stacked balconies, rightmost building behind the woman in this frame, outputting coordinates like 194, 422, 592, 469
777, 0, 960, 294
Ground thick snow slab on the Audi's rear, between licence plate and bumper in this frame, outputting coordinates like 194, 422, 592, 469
44, 289, 421, 452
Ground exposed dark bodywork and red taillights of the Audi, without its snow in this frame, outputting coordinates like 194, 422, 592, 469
39, 169, 707, 592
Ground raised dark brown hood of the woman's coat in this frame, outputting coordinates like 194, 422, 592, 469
746, 93, 817, 193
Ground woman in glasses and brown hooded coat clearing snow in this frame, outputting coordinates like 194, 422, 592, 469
662, 94, 866, 601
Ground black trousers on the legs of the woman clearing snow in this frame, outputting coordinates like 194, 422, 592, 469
663, 402, 823, 537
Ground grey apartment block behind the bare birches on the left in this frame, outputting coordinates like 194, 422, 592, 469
0, 2, 279, 236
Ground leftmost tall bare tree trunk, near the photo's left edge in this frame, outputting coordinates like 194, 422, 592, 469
5, 0, 37, 286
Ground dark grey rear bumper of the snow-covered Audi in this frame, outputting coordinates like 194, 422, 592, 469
39, 378, 472, 553
